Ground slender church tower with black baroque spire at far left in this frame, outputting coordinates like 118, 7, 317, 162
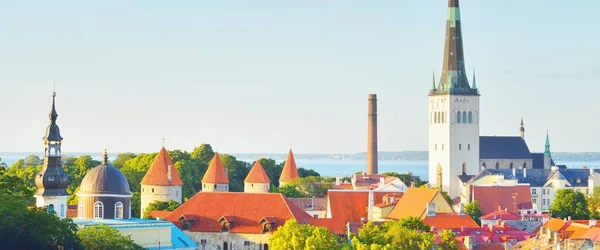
34, 89, 70, 218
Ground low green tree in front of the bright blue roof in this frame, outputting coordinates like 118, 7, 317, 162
77, 225, 144, 250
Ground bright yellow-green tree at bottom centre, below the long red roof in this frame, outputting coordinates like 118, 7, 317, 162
270, 219, 339, 250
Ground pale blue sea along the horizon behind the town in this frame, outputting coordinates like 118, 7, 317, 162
0, 153, 600, 181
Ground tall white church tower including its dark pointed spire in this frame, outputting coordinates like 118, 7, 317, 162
429, 0, 479, 198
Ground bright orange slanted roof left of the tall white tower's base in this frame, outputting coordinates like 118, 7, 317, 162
388, 188, 439, 219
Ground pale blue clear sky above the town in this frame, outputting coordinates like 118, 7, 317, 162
0, 0, 600, 153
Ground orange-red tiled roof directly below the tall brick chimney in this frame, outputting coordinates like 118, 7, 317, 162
327, 190, 401, 222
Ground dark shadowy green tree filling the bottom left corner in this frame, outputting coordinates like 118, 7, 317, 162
0, 193, 82, 249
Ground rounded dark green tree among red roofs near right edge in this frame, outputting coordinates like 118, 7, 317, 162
550, 189, 590, 220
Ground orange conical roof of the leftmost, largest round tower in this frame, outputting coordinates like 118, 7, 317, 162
141, 147, 183, 186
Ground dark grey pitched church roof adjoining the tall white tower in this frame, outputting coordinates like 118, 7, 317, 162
479, 136, 531, 159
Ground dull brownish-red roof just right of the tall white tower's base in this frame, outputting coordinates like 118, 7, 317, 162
473, 185, 533, 214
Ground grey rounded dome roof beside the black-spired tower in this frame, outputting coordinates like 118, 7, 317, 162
77, 162, 132, 196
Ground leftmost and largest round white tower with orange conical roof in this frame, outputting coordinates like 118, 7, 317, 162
140, 147, 183, 218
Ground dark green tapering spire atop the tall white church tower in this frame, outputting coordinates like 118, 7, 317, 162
431, 0, 477, 95
